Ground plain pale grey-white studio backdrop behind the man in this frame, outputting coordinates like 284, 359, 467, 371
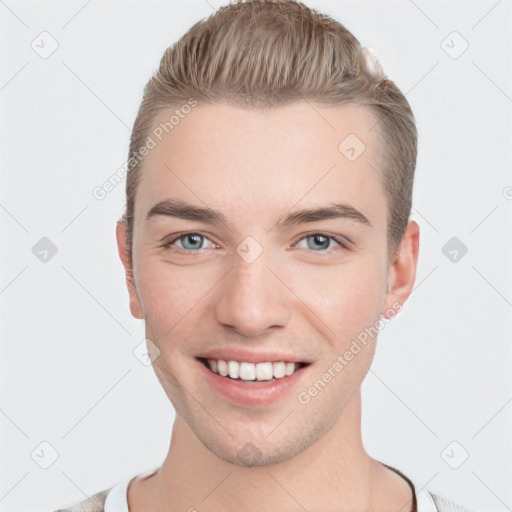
0, 0, 512, 512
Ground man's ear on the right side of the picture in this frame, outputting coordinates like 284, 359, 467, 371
382, 220, 420, 318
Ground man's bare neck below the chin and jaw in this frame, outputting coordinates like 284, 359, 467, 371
129, 390, 398, 512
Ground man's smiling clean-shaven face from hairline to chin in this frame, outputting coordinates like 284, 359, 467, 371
118, 102, 414, 465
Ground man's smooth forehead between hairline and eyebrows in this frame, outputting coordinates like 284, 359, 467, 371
135, 102, 385, 230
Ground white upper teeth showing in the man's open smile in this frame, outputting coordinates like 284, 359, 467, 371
198, 357, 310, 383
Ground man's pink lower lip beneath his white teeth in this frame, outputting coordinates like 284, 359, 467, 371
197, 360, 309, 405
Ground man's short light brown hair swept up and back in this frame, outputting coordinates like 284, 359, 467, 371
122, 0, 417, 261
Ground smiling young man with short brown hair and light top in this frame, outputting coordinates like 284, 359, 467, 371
55, 0, 476, 512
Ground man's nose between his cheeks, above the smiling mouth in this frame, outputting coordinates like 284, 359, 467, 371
215, 257, 291, 337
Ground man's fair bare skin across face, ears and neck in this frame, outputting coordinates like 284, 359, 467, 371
116, 101, 419, 512
